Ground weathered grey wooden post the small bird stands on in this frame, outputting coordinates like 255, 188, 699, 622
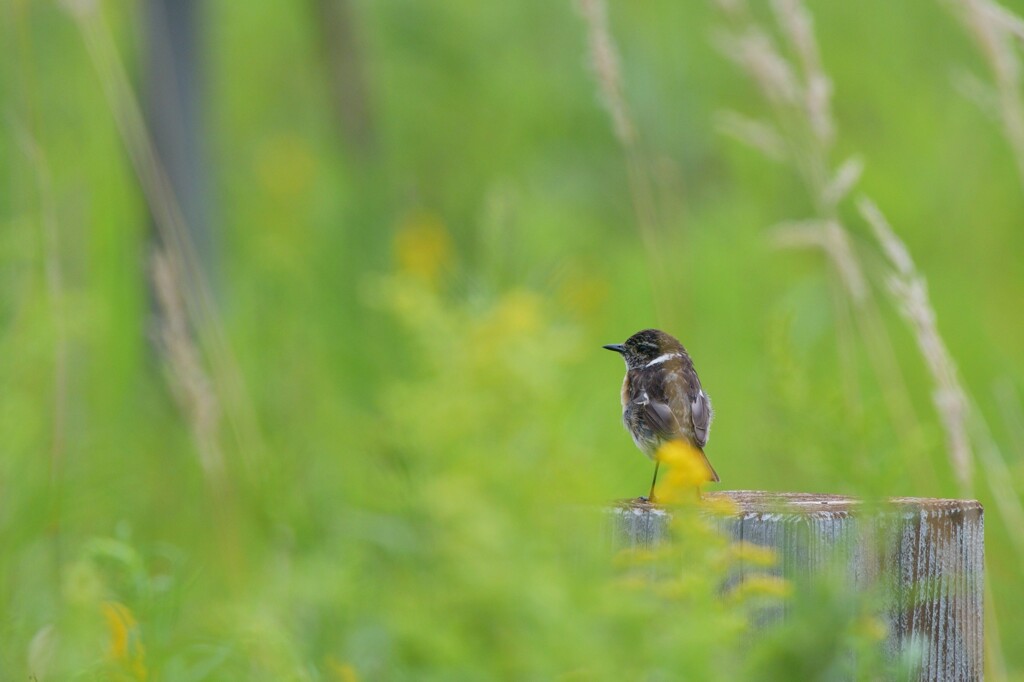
612, 491, 985, 682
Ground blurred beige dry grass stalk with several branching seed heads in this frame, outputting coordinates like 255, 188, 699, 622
718, 0, 916, 437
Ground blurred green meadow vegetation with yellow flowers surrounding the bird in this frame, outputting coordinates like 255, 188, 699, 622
0, 0, 1024, 680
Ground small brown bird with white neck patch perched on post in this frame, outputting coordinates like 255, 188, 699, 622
603, 329, 719, 501
